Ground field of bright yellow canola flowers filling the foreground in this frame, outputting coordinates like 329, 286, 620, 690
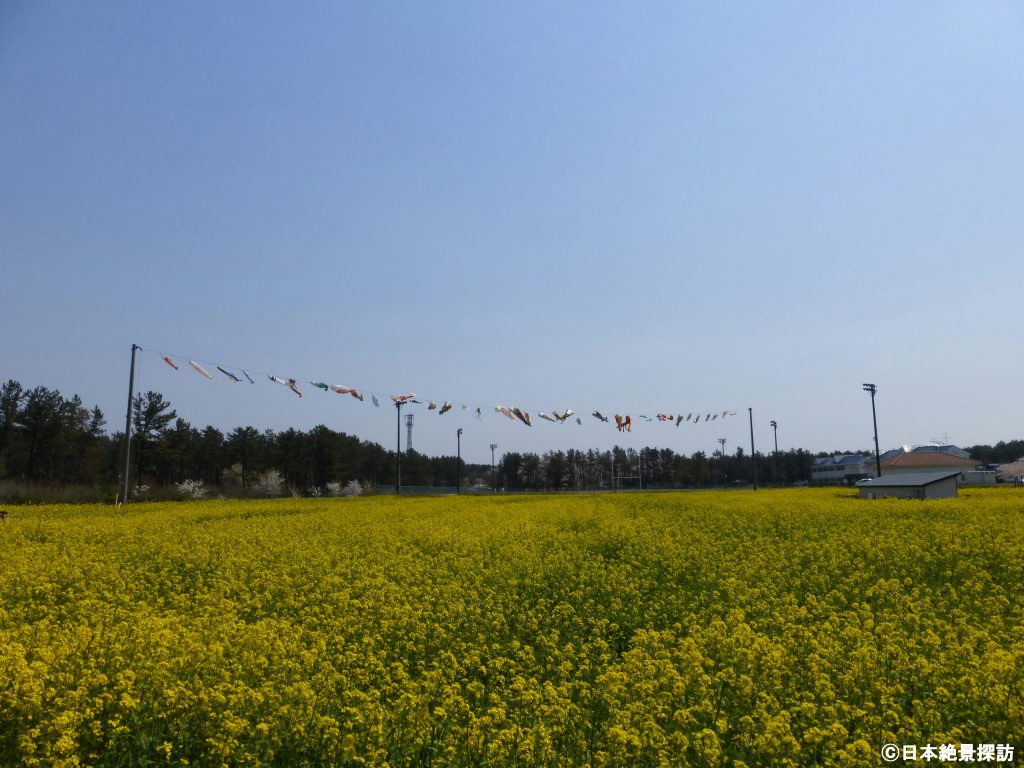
0, 488, 1024, 768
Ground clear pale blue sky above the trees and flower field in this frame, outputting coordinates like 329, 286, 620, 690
0, 0, 1024, 462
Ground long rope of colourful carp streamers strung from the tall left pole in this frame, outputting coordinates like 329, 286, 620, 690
138, 347, 736, 432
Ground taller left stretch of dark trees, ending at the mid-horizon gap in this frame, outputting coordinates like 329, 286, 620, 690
0, 380, 490, 496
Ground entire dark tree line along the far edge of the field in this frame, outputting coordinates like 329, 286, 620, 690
0, 380, 1024, 493
